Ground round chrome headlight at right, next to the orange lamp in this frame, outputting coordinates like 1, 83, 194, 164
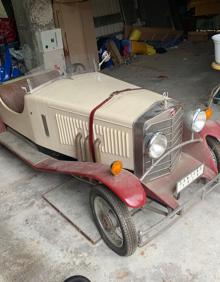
186, 109, 206, 132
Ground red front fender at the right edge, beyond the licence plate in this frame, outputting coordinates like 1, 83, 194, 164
184, 120, 220, 176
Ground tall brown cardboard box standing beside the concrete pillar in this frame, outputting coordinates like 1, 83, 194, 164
53, 0, 98, 70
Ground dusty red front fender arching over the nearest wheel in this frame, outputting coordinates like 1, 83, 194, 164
32, 158, 146, 208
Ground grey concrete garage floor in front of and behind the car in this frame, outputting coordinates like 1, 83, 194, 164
0, 40, 220, 282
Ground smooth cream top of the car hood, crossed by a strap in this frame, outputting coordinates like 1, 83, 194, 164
29, 73, 163, 127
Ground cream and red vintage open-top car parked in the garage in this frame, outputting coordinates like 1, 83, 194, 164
0, 67, 220, 256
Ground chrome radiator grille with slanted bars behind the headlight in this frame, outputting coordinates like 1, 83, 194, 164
144, 108, 183, 181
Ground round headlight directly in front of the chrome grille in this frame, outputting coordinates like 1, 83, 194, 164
146, 132, 168, 159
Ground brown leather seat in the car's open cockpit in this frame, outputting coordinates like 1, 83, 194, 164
0, 71, 60, 113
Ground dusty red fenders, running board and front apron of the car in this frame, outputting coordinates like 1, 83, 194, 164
0, 118, 220, 209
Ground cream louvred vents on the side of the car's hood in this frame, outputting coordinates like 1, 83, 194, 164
55, 114, 130, 158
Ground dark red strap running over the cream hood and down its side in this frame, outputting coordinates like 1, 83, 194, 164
89, 87, 143, 162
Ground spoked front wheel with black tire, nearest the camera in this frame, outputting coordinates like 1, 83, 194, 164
90, 185, 138, 256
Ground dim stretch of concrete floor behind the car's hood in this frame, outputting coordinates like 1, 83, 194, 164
106, 42, 220, 111
